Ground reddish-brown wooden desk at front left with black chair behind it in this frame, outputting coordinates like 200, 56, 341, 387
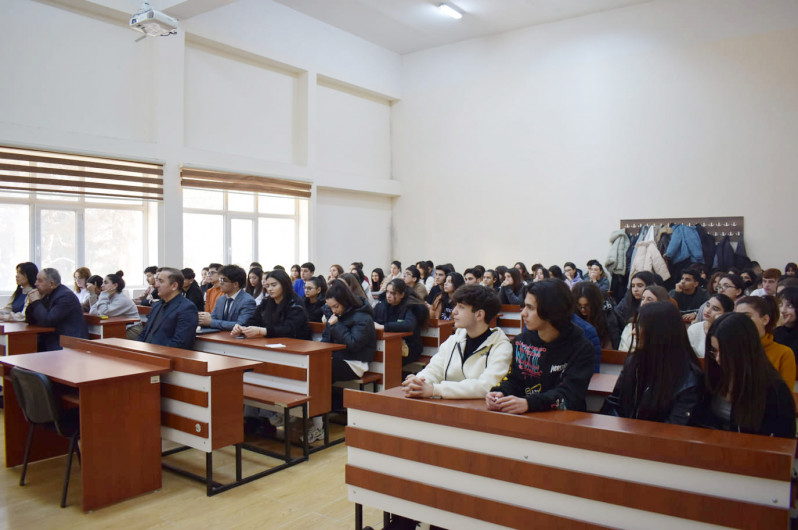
0, 342, 170, 511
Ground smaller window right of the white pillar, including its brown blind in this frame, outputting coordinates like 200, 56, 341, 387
182, 168, 310, 271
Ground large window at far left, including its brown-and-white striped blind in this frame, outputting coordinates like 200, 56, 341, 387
0, 147, 163, 294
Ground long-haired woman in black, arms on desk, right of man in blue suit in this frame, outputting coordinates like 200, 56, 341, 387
231, 270, 316, 340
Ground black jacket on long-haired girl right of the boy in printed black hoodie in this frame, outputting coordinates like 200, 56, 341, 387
601, 354, 704, 425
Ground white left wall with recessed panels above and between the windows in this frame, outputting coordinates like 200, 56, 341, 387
0, 0, 401, 265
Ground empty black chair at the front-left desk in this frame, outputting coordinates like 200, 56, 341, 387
11, 368, 80, 508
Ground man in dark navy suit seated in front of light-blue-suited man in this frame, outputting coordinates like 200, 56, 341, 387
136, 267, 197, 350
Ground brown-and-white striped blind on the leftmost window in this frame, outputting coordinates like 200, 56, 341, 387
0, 146, 163, 201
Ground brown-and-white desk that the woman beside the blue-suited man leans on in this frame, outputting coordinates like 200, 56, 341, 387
194, 331, 345, 417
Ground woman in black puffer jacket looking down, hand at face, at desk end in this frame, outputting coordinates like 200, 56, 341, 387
321, 282, 377, 382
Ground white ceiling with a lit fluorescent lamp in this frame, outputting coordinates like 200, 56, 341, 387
275, 0, 652, 54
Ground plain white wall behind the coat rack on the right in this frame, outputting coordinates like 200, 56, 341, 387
393, 0, 798, 267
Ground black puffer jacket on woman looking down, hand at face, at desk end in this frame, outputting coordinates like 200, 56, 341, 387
321, 302, 377, 363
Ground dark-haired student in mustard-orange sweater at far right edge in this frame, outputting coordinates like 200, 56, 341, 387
734, 295, 795, 388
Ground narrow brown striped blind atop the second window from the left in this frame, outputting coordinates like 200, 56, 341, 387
180, 167, 311, 198
